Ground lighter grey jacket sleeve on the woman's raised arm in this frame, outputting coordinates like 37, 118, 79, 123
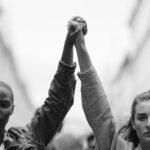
78, 67, 125, 150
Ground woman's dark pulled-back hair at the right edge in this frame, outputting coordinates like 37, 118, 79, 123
118, 90, 150, 147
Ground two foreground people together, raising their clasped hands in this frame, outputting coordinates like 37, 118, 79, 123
0, 16, 150, 150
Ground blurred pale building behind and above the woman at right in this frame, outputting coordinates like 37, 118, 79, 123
109, 0, 150, 124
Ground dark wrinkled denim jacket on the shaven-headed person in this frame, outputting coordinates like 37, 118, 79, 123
3, 61, 76, 150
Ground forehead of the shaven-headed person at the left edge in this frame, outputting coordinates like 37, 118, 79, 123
0, 86, 12, 100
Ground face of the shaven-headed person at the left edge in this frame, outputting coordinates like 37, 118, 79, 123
0, 86, 14, 129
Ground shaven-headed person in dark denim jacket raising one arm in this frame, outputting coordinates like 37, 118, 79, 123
0, 17, 76, 150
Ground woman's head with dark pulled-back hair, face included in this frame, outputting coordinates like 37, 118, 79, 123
119, 90, 150, 147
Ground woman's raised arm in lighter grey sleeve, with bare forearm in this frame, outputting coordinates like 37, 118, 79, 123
72, 17, 115, 150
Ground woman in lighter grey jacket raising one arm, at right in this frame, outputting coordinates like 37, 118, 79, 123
72, 17, 150, 150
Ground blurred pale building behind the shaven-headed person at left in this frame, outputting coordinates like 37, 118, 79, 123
0, 1, 33, 129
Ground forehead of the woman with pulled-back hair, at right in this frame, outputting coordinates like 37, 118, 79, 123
135, 100, 150, 115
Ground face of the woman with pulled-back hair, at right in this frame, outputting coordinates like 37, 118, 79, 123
132, 101, 150, 143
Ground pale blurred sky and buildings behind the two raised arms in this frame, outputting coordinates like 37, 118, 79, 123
0, 0, 150, 149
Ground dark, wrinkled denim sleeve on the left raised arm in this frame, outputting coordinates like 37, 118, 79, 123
29, 61, 76, 145
